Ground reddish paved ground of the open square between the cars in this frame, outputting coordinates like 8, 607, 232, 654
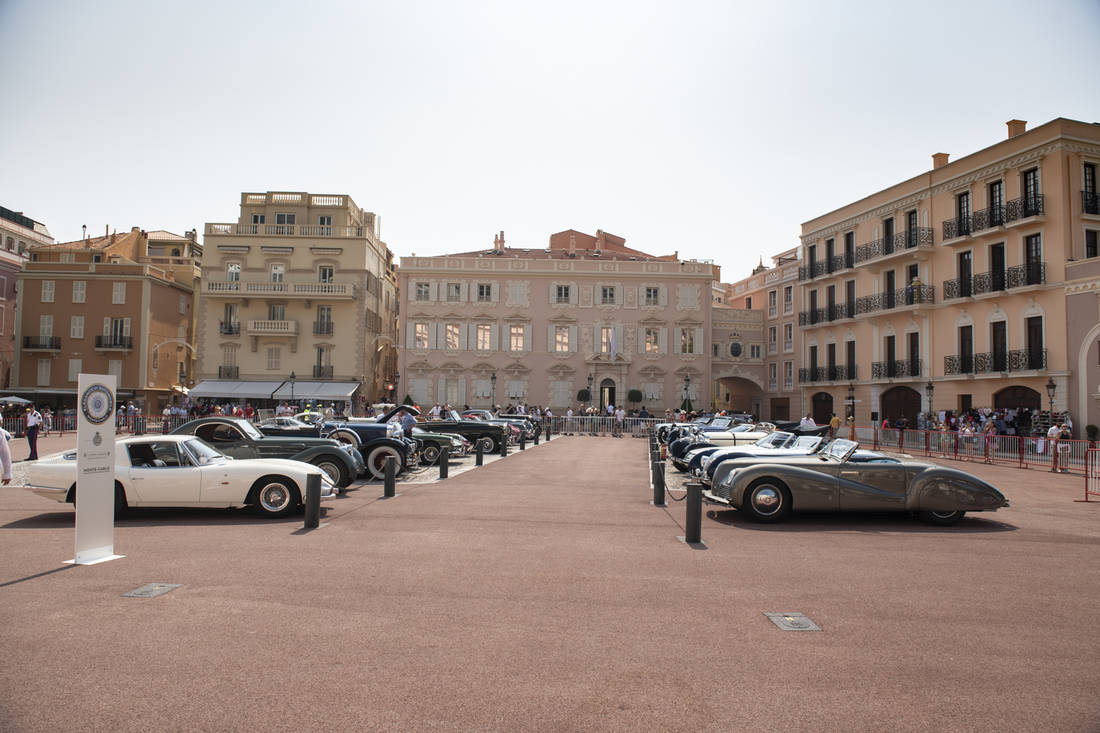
0, 437, 1100, 731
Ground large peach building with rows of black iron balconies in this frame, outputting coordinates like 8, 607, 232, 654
799, 118, 1100, 433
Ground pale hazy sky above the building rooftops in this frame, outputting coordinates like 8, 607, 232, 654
0, 0, 1100, 281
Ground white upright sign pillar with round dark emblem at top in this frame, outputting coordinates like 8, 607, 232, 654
69, 374, 122, 565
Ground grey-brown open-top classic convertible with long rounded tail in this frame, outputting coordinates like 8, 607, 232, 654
703, 439, 1009, 525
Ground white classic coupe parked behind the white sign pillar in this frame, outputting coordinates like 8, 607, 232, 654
24, 435, 337, 517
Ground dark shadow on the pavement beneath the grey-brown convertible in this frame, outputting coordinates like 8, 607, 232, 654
706, 510, 1019, 534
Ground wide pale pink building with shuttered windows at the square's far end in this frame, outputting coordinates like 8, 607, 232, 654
397, 230, 718, 412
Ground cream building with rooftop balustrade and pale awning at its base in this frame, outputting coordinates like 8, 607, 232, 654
193, 192, 397, 407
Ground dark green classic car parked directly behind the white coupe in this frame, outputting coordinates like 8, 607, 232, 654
172, 417, 363, 488
